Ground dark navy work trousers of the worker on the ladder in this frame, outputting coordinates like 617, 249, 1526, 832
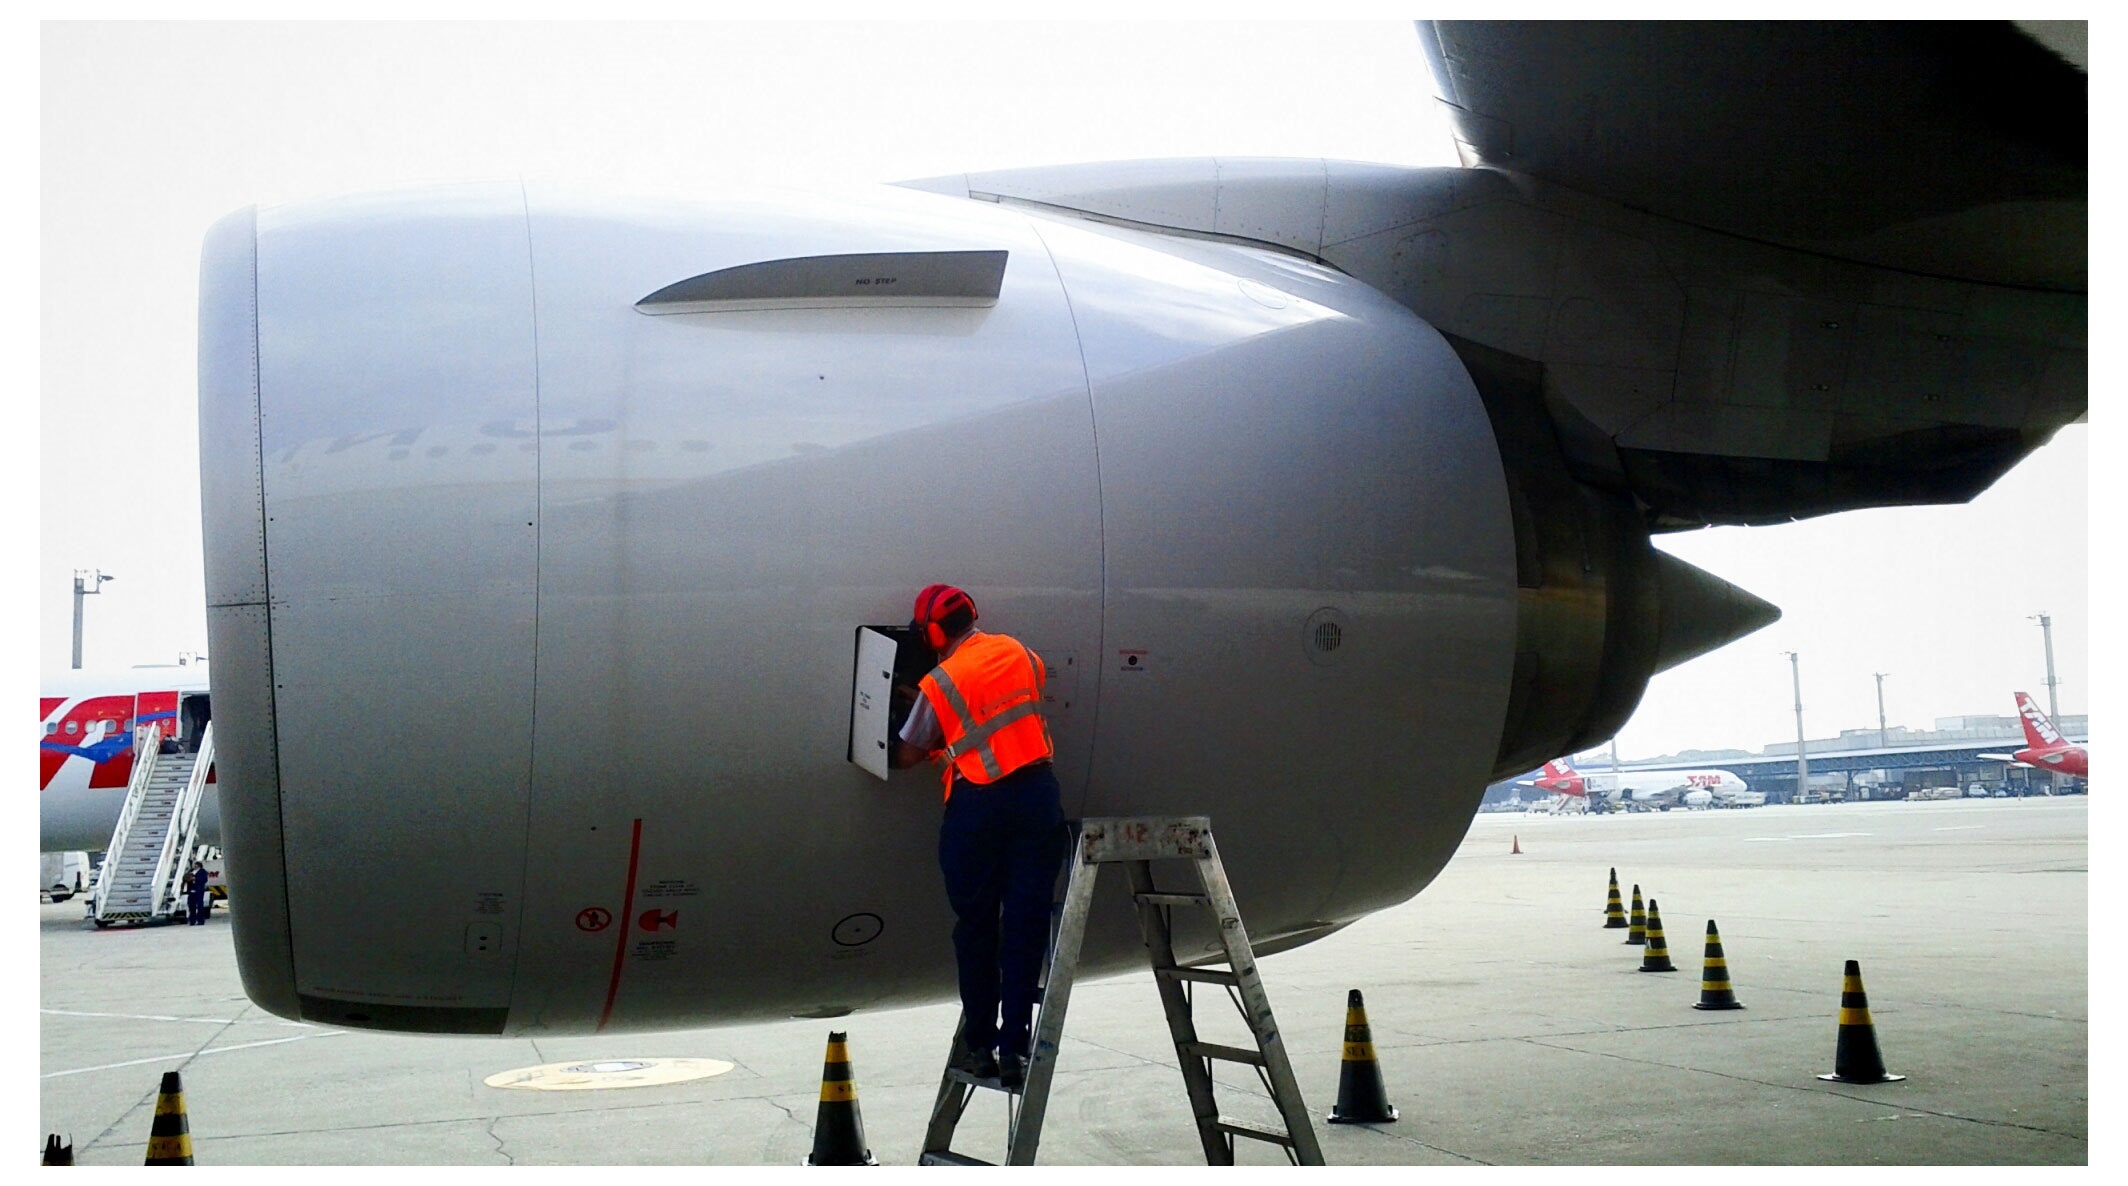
938, 762, 1066, 1056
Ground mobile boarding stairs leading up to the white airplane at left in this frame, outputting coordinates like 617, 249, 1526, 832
87, 724, 215, 926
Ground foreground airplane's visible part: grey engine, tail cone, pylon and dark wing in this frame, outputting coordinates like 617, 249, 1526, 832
183, 23, 2088, 1035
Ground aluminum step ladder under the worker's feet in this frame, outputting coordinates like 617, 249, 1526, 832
917, 816, 1324, 1165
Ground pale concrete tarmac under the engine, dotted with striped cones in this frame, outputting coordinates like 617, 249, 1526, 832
38, 796, 2090, 1167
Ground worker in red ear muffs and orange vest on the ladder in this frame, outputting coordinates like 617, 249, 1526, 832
890, 586, 1064, 1090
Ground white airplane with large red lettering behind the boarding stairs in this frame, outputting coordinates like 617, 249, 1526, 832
36, 660, 221, 852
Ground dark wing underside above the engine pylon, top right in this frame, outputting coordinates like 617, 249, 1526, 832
1419, 21, 2088, 292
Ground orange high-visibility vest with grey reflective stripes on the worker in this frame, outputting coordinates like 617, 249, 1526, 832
917, 635, 1055, 798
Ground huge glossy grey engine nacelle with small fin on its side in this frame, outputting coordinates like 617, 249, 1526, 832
200, 185, 1753, 1033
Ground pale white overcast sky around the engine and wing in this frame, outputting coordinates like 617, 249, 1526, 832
23, 21, 2098, 760
